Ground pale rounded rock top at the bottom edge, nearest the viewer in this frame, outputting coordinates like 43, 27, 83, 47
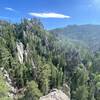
40, 89, 70, 100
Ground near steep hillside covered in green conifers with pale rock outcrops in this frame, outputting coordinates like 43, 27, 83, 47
0, 19, 100, 100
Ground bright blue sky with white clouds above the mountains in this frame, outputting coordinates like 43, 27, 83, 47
0, 0, 100, 29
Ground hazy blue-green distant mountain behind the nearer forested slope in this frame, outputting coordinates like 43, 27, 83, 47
50, 25, 100, 51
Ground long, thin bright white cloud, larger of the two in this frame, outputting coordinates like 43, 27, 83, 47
29, 12, 70, 18
